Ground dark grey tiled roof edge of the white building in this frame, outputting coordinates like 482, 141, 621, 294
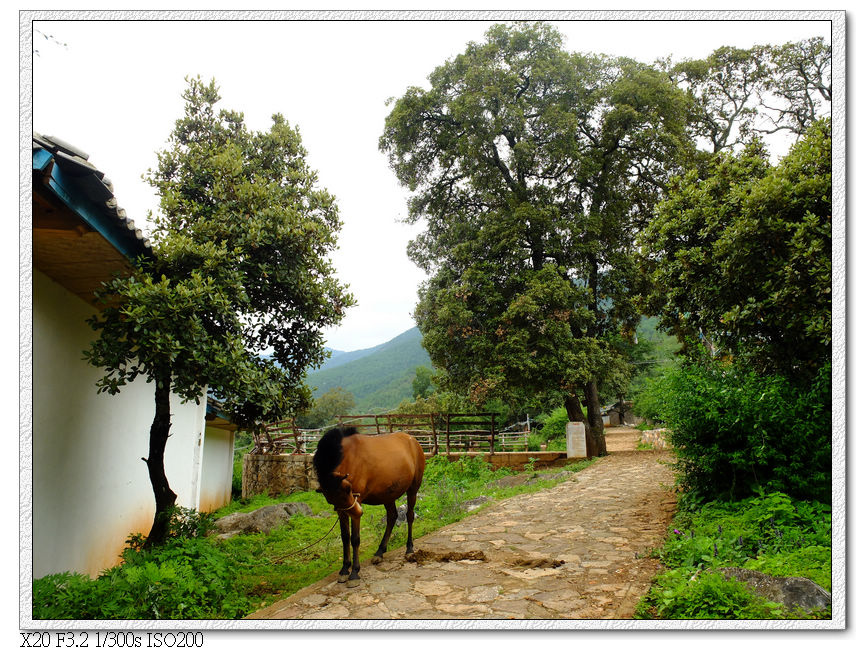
33, 132, 150, 254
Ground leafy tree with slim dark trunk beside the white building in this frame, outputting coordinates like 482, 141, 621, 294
85, 78, 352, 546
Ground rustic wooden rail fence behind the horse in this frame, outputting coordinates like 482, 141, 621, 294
252, 413, 529, 455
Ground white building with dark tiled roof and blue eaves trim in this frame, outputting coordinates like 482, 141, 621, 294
30, 134, 235, 578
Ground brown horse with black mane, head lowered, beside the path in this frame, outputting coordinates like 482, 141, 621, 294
312, 427, 426, 587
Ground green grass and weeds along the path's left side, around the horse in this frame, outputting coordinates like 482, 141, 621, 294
33, 457, 591, 620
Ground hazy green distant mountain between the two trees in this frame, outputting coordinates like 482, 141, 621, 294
307, 327, 432, 413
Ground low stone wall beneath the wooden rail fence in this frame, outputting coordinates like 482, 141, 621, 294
241, 451, 567, 499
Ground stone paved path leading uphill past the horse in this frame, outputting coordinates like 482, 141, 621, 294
248, 427, 675, 620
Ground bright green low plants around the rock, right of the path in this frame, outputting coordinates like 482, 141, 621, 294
636, 492, 832, 619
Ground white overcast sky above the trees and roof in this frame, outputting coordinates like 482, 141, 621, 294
32, 14, 831, 350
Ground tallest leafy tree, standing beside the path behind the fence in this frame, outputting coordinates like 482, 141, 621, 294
380, 23, 687, 455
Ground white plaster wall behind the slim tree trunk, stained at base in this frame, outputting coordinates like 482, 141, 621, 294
32, 271, 205, 578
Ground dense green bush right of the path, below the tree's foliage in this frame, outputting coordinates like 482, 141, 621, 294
638, 361, 832, 502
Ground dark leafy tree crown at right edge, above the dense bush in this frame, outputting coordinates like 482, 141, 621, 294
641, 120, 832, 377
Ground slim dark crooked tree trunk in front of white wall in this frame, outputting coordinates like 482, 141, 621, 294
142, 374, 177, 548
